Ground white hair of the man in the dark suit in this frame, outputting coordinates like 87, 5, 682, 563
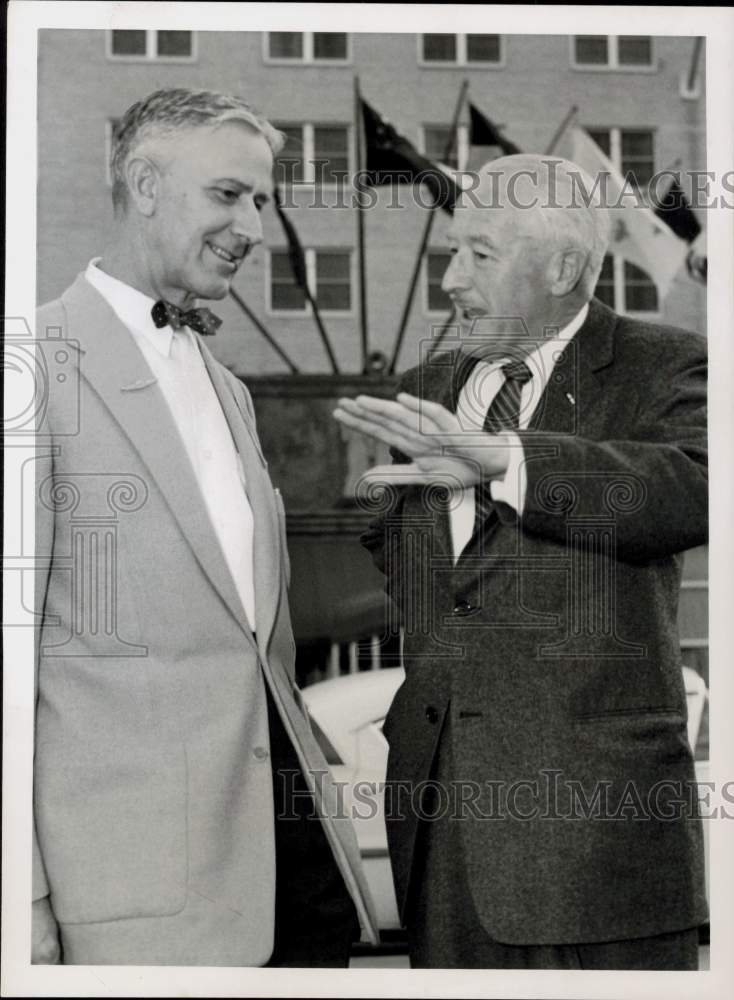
467, 153, 610, 298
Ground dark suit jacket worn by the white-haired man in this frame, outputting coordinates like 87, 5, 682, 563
363, 300, 707, 944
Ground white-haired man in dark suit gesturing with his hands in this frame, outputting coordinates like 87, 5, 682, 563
336, 156, 707, 969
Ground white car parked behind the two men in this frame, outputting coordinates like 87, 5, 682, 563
301, 667, 709, 930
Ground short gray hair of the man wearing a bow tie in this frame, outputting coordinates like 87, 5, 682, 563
110, 87, 285, 214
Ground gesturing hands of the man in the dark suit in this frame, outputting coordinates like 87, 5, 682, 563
334, 392, 508, 488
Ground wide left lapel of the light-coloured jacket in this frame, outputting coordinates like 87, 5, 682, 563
62, 275, 258, 631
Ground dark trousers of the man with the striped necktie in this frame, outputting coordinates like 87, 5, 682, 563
406, 714, 698, 970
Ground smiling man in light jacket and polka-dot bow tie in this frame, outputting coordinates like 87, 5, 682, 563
33, 90, 375, 966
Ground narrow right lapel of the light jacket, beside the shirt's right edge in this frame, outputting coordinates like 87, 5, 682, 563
200, 341, 281, 657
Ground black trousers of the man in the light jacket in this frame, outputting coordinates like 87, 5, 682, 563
267, 691, 360, 968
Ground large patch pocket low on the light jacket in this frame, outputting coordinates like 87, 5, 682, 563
35, 739, 188, 924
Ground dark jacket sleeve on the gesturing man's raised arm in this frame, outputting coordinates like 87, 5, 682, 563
504, 338, 708, 562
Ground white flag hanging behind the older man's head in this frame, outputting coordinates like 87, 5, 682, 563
571, 126, 688, 296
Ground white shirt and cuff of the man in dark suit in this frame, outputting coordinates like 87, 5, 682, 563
449, 303, 589, 562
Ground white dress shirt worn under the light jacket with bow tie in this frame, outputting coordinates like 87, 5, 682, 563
85, 258, 255, 631
